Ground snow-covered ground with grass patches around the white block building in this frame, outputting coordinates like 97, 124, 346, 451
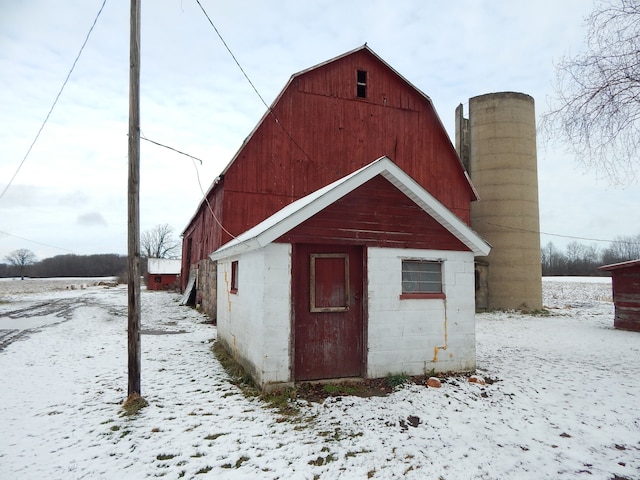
0, 278, 640, 480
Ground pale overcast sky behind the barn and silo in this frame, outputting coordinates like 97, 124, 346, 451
0, 0, 640, 261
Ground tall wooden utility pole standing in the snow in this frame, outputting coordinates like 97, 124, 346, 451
127, 0, 142, 395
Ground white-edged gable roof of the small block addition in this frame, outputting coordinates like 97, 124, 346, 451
209, 157, 491, 260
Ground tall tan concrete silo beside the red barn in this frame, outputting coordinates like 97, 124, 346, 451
456, 92, 542, 311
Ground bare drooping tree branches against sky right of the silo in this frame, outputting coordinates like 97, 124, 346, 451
541, 0, 640, 183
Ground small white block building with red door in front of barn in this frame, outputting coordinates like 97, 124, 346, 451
210, 157, 490, 389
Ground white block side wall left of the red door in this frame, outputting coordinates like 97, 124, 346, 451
218, 243, 291, 384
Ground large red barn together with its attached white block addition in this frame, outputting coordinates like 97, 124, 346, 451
182, 45, 539, 387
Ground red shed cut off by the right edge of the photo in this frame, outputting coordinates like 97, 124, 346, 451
600, 259, 640, 332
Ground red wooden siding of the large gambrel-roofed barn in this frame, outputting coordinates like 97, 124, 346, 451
182, 48, 475, 281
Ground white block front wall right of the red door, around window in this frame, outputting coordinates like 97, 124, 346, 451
367, 248, 476, 378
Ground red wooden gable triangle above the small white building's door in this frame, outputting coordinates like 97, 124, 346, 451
277, 176, 469, 251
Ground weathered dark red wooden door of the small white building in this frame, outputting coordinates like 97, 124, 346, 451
293, 245, 364, 381
